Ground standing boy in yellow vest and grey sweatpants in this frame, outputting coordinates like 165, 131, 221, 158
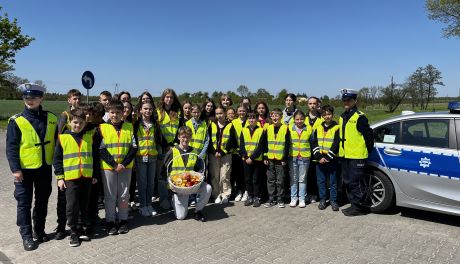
99, 99, 137, 235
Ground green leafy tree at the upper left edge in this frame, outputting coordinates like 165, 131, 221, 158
0, 6, 34, 81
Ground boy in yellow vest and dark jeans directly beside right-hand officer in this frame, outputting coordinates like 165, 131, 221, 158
311, 105, 340, 211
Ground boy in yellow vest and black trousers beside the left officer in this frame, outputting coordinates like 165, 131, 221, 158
53, 108, 98, 247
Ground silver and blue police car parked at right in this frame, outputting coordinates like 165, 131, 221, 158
367, 102, 460, 215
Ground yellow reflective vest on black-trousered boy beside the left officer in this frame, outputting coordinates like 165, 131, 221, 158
59, 130, 94, 181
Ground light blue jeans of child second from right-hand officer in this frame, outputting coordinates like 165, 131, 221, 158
289, 158, 310, 200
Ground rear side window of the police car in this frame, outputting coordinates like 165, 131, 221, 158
402, 119, 449, 148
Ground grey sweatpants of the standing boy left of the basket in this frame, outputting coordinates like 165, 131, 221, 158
102, 169, 131, 222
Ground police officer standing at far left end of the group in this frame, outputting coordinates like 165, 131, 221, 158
6, 83, 57, 251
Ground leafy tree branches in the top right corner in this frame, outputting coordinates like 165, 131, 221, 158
425, 0, 460, 38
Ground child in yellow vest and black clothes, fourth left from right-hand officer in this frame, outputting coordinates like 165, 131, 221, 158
240, 111, 267, 207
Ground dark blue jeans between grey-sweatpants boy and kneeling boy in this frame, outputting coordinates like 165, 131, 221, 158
136, 157, 157, 207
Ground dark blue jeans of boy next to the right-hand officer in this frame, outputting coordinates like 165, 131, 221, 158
316, 161, 337, 202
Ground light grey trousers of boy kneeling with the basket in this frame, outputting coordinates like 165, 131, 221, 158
172, 183, 211, 220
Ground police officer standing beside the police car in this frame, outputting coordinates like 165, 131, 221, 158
339, 89, 374, 216
